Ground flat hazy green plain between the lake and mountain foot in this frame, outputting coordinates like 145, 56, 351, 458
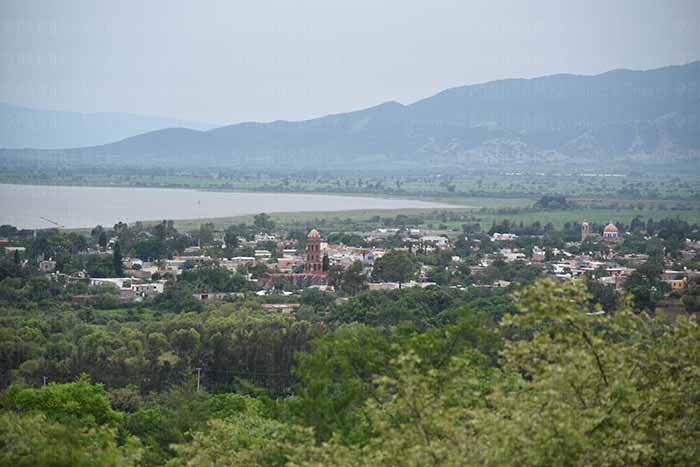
0, 167, 700, 200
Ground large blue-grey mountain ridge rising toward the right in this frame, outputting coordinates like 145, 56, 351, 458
0, 61, 700, 170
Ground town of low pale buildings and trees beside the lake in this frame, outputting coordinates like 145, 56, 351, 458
0, 213, 700, 312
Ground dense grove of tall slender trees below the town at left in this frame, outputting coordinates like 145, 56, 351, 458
0, 302, 320, 394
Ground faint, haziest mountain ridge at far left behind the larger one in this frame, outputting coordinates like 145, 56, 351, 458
0, 103, 216, 149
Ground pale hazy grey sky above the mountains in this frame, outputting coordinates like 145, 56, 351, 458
0, 0, 700, 124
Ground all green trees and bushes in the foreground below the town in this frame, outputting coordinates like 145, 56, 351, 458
0, 281, 700, 466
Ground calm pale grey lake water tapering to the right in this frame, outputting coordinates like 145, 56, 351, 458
0, 184, 454, 229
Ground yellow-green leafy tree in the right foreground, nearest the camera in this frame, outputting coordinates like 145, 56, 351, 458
480, 281, 700, 465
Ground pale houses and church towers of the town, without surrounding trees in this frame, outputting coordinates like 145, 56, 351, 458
5, 222, 700, 310
